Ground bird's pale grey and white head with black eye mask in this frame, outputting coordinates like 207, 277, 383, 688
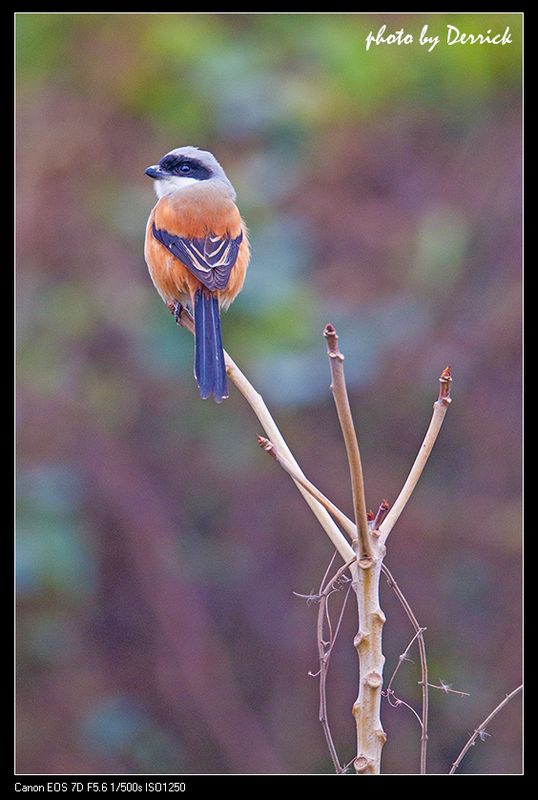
145, 145, 235, 200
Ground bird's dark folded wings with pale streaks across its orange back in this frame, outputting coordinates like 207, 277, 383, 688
152, 223, 243, 291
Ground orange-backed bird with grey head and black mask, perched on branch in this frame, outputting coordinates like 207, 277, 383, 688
144, 145, 250, 403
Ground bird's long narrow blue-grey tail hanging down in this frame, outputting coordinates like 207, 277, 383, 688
194, 289, 228, 403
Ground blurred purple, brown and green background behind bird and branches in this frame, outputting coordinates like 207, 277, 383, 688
16, 13, 521, 773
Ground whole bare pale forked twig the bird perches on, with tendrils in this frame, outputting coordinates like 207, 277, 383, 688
170, 304, 463, 774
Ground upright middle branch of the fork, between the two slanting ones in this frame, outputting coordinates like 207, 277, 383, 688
323, 323, 373, 559
